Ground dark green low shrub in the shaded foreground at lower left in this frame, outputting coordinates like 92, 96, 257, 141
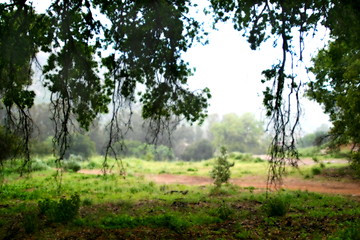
38, 194, 80, 222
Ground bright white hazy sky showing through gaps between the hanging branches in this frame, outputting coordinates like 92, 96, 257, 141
29, 0, 329, 132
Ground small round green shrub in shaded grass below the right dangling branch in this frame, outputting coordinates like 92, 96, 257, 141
263, 194, 290, 217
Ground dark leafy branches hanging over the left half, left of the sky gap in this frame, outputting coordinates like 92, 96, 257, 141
0, 0, 210, 176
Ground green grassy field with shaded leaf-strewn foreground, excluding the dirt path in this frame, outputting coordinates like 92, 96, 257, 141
0, 157, 360, 239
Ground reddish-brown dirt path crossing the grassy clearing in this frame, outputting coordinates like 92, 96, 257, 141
79, 169, 360, 197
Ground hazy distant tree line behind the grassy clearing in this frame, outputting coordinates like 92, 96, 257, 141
23, 104, 269, 161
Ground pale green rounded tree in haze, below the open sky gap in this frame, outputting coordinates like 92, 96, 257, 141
210, 113, 264, 153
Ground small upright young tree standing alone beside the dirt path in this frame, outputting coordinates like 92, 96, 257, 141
210, 147, 235, 188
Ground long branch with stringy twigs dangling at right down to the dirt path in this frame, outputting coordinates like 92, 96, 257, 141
211, 0, 333, 189
